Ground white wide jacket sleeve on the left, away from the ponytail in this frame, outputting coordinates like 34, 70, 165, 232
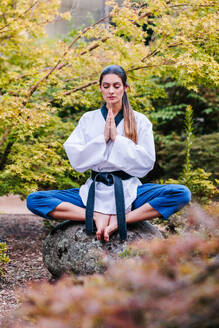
64, 116, 106, 172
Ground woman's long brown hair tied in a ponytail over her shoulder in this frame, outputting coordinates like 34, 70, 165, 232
99, 65, 138, 144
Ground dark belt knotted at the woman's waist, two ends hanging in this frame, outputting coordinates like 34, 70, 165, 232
85, 171, 132, 240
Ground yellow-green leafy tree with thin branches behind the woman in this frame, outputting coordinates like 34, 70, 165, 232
0, 0, 218, 195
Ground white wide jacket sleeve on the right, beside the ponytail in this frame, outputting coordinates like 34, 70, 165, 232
107, 116, 155, 178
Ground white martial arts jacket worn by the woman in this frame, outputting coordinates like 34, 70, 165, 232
64, 109, 155, 214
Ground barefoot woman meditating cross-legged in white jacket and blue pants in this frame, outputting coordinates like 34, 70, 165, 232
27, 65, 191, 242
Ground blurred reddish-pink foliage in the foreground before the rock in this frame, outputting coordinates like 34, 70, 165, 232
4, 206, 219, 328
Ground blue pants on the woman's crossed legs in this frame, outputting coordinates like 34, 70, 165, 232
27, 183, 191, 220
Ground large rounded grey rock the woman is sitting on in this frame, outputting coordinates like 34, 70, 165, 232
43, 221, 162, 277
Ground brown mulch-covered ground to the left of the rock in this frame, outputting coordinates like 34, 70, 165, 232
0, 214, 51, 320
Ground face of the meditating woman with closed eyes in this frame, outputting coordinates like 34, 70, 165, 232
100, 74, 127, 105
